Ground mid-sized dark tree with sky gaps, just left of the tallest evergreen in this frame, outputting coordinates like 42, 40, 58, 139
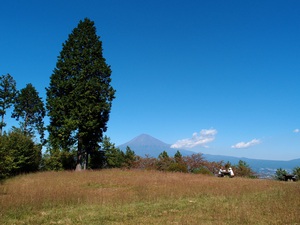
12, 84, 45, 143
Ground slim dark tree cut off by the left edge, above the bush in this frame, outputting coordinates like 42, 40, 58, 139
0, 74, 17, 135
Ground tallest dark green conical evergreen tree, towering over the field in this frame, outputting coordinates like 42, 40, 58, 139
46, 19, 115, 170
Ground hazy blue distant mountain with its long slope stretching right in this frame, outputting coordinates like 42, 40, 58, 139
118, 134, 300, 174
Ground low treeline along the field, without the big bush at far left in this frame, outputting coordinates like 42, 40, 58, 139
43, 136, 256, 178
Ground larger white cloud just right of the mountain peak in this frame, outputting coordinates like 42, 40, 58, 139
171, 129, 218, 148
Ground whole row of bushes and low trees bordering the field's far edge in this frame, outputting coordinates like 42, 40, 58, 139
0, 132, 255, 179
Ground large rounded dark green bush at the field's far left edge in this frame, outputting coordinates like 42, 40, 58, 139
0, 129, 42, 178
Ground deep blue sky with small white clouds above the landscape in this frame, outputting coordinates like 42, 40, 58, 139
0, 0, 300, 160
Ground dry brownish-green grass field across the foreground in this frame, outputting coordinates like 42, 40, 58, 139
0, 170, 300, 225
